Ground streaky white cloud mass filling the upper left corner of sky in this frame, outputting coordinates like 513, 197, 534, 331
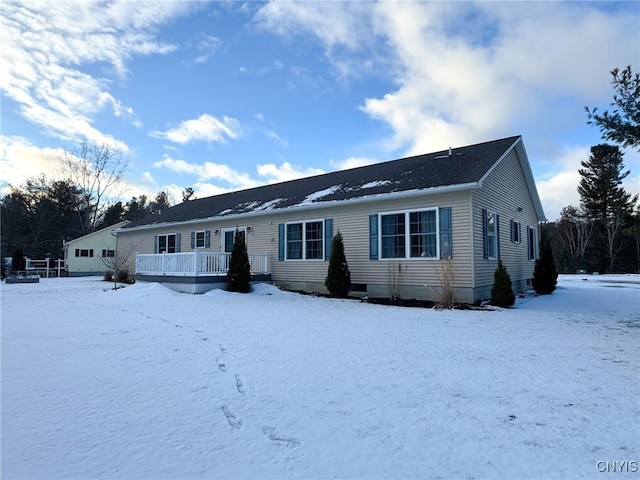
0, 1, 197, 146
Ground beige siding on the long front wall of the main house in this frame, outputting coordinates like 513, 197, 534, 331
119, 190, 473, 296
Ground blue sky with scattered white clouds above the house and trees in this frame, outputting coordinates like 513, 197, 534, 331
0, 0, 640, 220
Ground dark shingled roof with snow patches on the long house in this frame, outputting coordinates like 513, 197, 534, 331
123, 136, 520, 230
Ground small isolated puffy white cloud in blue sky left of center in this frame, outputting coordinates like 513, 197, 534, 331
149, 113, 242, 144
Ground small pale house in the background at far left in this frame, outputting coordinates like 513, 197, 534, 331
62, 220, 130, 277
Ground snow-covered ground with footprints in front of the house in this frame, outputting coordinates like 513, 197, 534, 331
0, 275, 640, 479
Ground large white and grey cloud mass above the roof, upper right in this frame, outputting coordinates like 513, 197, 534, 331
256, 2, 640, 154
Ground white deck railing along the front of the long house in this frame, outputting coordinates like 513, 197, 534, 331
136, 252, 269, 277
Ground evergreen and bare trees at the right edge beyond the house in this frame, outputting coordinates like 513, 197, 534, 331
542, 66, 640, 273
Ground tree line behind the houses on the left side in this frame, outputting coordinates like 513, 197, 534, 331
0, 142, 193, 259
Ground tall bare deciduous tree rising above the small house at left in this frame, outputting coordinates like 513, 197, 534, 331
62, 141, 127, 234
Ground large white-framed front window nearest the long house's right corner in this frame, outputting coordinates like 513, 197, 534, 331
379, 208, 440, 259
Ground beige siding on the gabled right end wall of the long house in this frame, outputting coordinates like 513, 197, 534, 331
473, 149, 539, 291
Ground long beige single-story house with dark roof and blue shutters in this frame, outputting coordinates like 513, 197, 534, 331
118, 136, 545, 302
